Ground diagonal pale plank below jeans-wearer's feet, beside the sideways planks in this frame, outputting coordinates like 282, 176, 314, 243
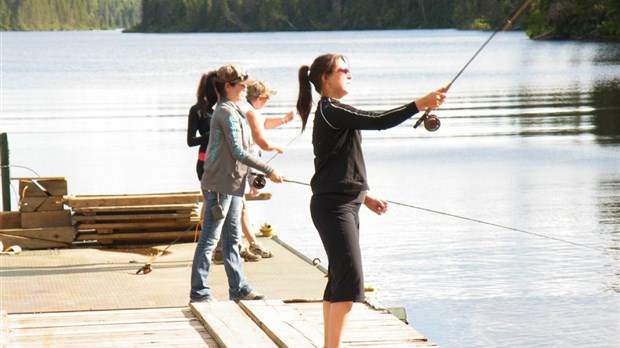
190, 301, 277, 348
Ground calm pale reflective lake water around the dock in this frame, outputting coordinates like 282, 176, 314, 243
0, 30, 620, 347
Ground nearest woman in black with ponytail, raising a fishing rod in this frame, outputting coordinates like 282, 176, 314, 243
297, 54, 446, 348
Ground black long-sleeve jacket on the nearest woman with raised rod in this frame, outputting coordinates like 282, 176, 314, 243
310, 97, 419, 195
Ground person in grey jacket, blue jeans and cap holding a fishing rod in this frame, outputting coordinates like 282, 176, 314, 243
190, 65, 283, 302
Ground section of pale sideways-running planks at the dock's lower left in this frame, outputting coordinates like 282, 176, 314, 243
9, 307, 218, 348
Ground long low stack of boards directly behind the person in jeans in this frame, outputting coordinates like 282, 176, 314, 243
65, 192, 201, 244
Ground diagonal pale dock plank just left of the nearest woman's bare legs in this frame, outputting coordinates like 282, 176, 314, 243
239, 300, 323, 348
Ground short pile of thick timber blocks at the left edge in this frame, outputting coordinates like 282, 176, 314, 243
0, 177, 75, 249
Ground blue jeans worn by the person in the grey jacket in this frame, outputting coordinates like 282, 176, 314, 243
189, 190, 252, 301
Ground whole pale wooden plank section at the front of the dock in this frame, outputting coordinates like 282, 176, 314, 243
2, 300, 435, 348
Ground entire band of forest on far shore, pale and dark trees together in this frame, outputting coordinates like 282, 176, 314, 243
0, 0, 620, 40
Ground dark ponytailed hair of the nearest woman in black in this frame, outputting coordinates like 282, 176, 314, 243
297, 53, 347, 132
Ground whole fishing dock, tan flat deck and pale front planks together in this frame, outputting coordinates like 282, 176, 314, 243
0, 197, 435, 348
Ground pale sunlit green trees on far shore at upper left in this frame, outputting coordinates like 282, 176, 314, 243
0, 0, 142, 31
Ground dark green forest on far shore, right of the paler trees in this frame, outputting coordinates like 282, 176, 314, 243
132, 0, 620, 40
